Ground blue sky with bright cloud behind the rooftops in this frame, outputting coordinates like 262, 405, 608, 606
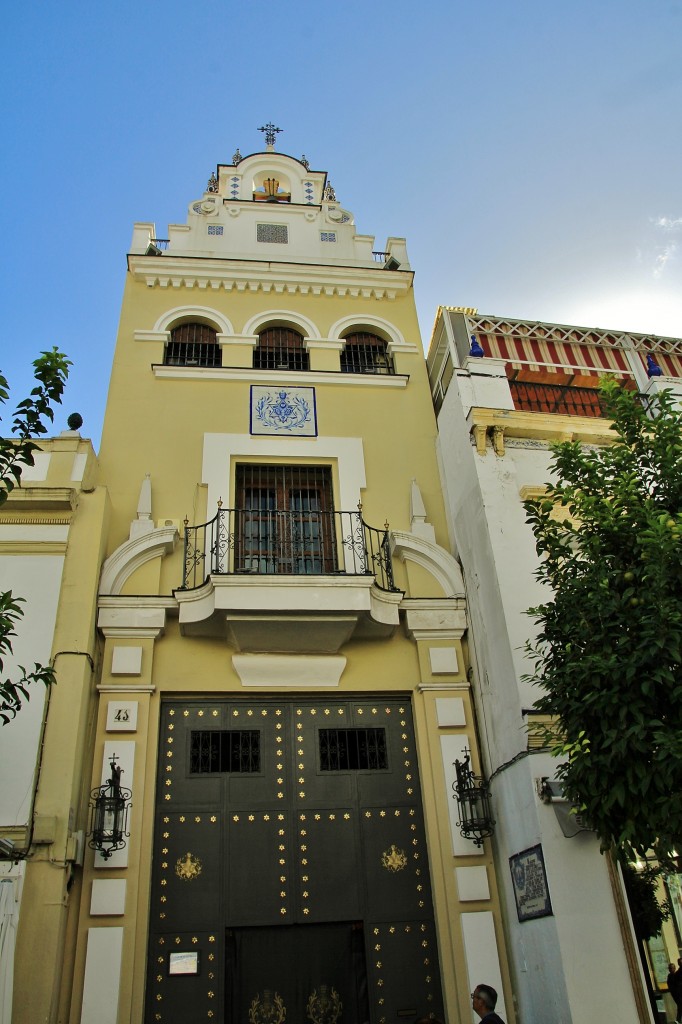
0, 0, 682, 444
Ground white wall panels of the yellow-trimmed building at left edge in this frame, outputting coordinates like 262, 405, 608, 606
0, 557, 67, 825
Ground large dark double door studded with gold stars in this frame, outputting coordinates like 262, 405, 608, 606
146, 698, 442, 1024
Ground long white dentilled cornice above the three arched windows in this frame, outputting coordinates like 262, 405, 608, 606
128, 255, 413, 299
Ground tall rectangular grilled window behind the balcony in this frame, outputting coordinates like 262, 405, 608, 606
235, 466, 337, 575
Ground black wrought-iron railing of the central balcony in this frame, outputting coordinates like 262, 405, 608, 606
180, 507, 398, 591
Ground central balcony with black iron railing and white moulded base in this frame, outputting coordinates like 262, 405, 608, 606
175, 507, 402, 653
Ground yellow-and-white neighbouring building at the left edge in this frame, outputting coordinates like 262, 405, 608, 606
0, 430, 102, 1024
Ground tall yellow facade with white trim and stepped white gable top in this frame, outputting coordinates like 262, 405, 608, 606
14, 147, 513, 1024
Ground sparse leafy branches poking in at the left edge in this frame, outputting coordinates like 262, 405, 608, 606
0, 348, 71, 725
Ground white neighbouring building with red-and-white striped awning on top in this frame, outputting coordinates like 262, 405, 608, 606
428, 307, 682, 1024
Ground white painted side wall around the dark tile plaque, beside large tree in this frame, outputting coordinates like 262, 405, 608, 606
438, 376, 637, 1024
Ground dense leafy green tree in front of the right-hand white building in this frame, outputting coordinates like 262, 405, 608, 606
525, 380, 682, 863
